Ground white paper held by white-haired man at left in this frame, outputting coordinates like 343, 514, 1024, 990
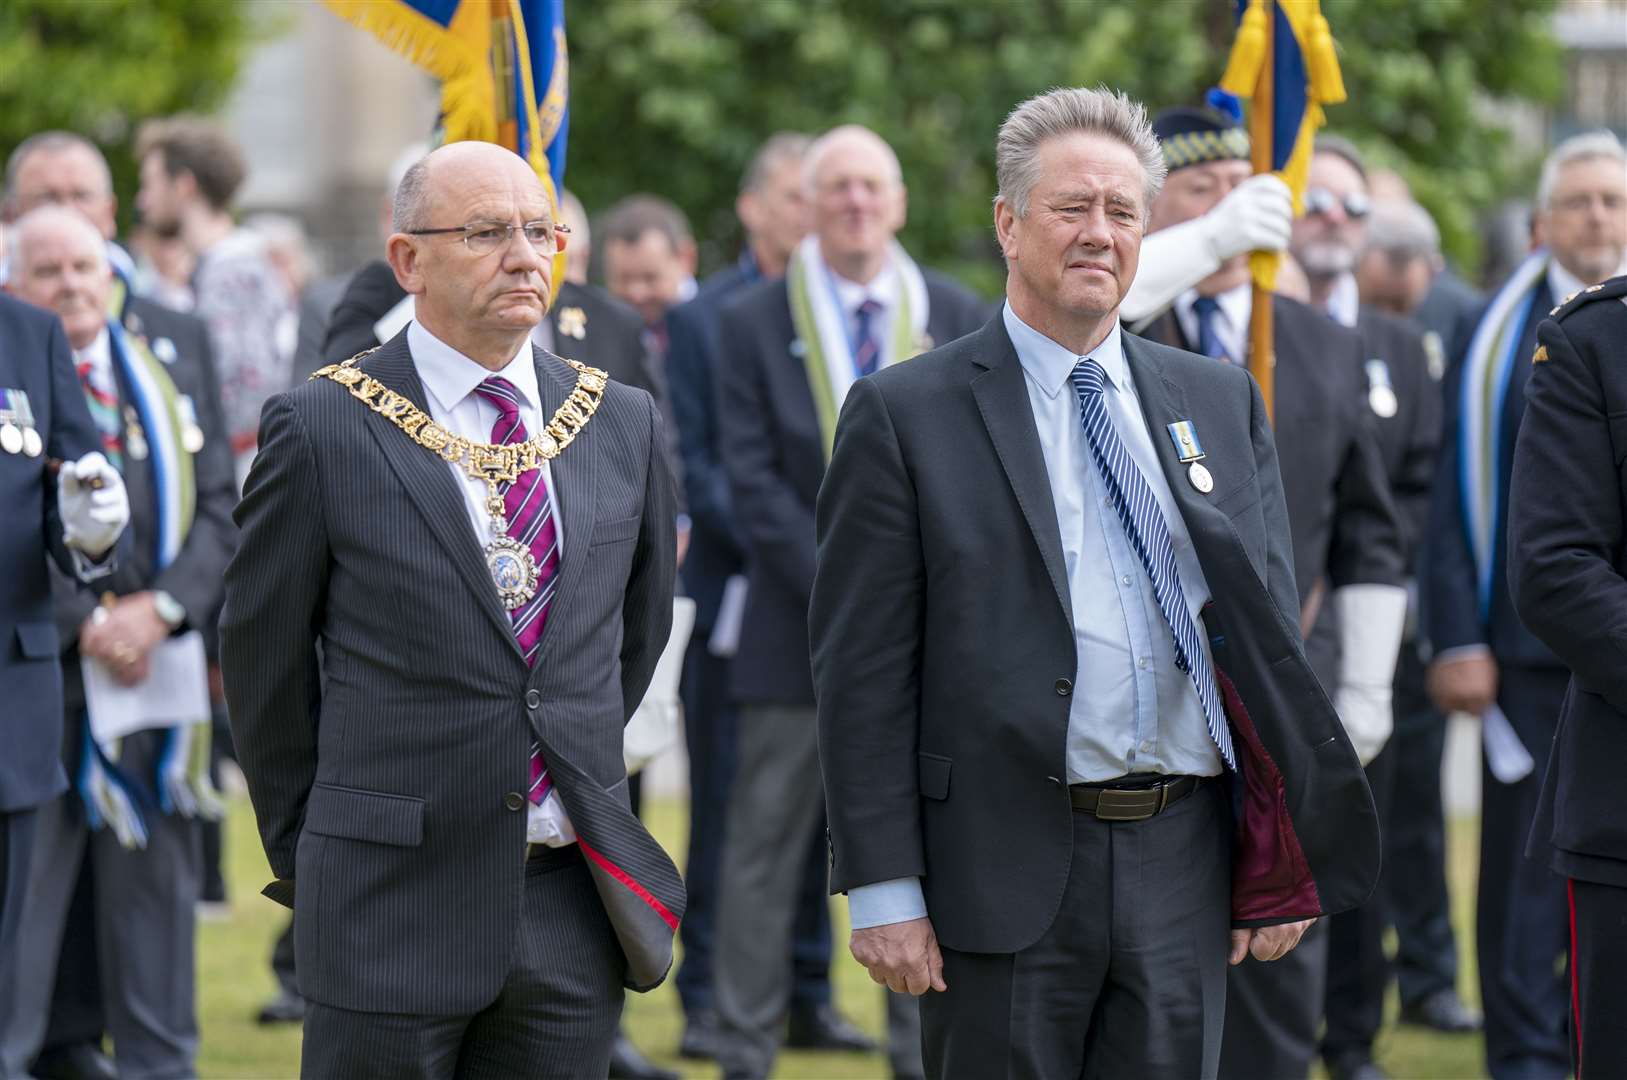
80, 629, 210, 743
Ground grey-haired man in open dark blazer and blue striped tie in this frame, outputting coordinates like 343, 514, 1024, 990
810, 89, 1378, 1077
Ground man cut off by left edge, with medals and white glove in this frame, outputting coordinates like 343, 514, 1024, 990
0, 286, 130, 1067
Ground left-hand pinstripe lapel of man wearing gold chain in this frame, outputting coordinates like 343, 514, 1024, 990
356, 330, 521, 657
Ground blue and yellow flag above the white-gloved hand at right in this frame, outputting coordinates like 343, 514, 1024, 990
1220, 0, 1344, 290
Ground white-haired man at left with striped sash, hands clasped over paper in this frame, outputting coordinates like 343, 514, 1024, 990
3, 207, 236, 1075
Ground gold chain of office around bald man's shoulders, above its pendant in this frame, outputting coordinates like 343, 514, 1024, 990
311, 346, 610, 494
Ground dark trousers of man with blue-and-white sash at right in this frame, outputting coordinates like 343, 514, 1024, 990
1474, 667, 1570, 1080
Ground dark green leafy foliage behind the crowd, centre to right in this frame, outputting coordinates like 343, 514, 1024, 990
568, 0, 1560, 291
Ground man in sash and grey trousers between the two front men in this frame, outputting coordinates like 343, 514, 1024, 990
714, 127, 983, 1077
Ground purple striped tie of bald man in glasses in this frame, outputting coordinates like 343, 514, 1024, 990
475, 376, 560, 805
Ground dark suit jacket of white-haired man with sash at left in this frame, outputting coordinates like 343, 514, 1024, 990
54, 298, 238, 722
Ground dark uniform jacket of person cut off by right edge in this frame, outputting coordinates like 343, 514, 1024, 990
1508, 277, 1627, 888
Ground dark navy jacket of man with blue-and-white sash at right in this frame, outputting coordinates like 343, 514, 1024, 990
1422, 278, 1559, 668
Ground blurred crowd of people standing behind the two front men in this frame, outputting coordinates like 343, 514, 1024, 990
0, 94, 1627, 1080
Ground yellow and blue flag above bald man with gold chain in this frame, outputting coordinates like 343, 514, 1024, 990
324, 0, 571, 268
